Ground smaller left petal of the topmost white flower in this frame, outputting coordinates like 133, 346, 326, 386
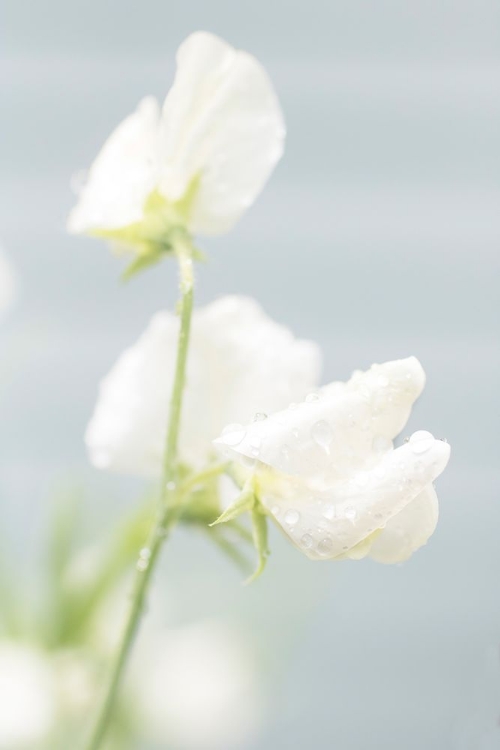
68, 97, 159, 233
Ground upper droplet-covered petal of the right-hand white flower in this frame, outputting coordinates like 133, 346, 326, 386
216, 357, 425, 487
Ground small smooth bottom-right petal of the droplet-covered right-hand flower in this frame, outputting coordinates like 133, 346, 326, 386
369, 484, 439, 563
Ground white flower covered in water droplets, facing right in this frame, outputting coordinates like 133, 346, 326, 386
216, 357, 450, 563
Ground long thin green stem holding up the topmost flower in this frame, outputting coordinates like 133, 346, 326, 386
86, 233, 193, 750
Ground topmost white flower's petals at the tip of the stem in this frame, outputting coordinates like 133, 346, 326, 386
68, 32, 285, 235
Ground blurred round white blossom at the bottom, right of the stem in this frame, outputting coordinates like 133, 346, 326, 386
134, 621, 261, 750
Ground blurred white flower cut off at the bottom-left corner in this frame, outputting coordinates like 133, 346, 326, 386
0, 641, 57, 750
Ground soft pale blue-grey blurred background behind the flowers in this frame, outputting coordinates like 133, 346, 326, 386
0, 0, 500, 750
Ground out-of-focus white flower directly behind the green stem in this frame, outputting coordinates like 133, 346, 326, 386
86, 297, 321, 477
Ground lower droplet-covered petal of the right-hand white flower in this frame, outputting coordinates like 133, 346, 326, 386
260, 438, 450, 560
